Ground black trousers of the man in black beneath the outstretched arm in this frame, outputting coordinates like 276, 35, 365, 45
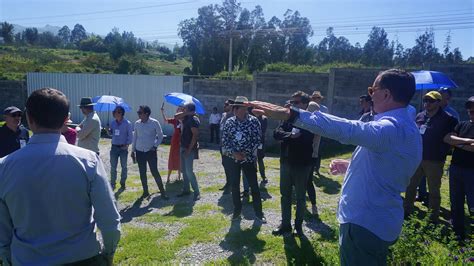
280, 159, 311, 228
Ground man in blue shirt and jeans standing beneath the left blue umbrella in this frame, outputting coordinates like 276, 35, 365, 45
110, 106, 133, 191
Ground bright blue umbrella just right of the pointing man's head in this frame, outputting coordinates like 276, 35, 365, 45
411, 70, 458, 90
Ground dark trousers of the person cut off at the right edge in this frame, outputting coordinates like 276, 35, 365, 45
449, 165, 474, 238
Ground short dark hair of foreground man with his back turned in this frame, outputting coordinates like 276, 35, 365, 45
26, 88, 69, 129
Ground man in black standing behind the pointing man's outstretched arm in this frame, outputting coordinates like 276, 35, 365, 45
272, 91, 314, 236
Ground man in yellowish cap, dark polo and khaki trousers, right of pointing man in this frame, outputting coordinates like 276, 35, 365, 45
404, 91, 457, 223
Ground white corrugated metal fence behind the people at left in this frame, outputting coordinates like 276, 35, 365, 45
27, 73, 183, 134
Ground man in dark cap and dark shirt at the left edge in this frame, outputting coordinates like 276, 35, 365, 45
0, 106, 30, 158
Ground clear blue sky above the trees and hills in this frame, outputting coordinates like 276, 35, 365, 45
0, 0, 474, 58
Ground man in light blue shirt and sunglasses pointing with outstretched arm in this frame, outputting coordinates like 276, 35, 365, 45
249, 69, 422, 265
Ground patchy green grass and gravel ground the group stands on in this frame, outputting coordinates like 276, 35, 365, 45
115, 147, 474, 265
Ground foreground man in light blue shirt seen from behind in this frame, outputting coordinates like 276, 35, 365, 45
0, 88, 120, 265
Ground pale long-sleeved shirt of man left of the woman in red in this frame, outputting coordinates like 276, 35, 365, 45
132, 117, 163, 152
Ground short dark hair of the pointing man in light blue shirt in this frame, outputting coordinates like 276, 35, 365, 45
379, 69, 416, 104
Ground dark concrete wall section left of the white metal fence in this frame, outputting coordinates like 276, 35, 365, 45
0, 80, 27, 120
